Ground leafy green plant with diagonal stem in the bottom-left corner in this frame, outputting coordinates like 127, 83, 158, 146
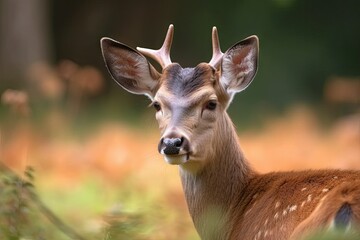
0, 165, 83, 240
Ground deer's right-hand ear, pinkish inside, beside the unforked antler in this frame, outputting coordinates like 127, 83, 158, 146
220, 36, 259, 99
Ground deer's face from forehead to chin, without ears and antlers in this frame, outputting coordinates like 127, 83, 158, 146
153, 63, 226, 164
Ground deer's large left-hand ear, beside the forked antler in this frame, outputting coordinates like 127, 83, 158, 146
100, 38, 161, 99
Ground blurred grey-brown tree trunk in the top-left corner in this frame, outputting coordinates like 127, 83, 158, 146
0, 0, 52, 85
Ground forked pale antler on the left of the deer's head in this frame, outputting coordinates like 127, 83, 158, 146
136, 24, 174, 69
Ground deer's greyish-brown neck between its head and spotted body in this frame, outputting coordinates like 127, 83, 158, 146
180, 114, 253, 239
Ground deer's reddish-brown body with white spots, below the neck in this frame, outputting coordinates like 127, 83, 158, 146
230, 170, 360, 240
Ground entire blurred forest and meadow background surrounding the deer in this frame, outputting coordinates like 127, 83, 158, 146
0, 0, 360, 239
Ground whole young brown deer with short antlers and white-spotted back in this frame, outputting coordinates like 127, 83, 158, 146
101, 24, 360, 240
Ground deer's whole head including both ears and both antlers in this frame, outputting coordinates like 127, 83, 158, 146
101, 25, 258, 170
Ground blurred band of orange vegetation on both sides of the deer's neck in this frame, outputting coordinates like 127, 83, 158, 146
0, 107, 360, 187
